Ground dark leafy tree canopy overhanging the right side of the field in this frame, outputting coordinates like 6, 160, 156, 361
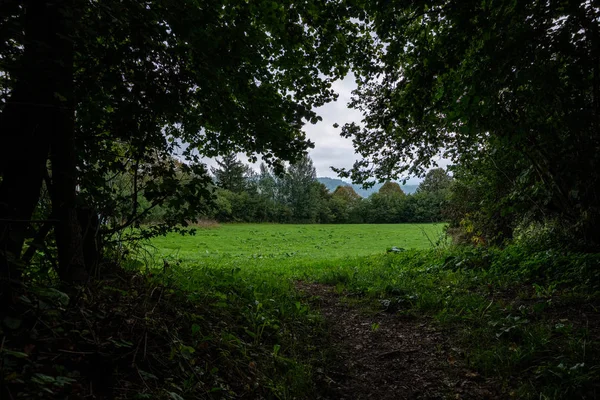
342, 0, 600, 243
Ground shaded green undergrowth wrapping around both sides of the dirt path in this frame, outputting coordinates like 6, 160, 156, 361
0, 227, 600, 400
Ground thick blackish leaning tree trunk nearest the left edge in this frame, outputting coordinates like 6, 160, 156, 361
0, 0, 64, 297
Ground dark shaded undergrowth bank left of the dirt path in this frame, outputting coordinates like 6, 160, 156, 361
0, 266, 328, 400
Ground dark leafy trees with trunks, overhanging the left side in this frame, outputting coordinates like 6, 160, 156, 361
0, 0, 365, 288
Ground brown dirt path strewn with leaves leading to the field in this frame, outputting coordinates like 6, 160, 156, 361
297, 282, 502, 400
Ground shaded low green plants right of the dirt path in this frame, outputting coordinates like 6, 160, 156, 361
314, 245, 600, 399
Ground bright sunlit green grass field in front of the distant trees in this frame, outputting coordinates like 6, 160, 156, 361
146, 224, 443, 265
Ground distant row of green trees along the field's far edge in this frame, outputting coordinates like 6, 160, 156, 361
142, 154, 453, 224
